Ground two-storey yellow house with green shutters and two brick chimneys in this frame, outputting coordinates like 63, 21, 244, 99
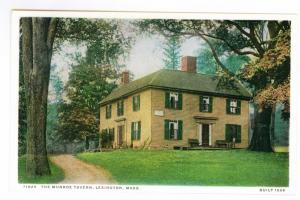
99, 56, 251, 149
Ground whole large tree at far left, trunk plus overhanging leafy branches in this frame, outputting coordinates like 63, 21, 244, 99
19, 18, 128, 176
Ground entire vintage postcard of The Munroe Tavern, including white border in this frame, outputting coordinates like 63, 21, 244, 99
7, 7, 295, 199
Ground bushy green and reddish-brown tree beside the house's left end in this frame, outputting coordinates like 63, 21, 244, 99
58, 63, 119, 141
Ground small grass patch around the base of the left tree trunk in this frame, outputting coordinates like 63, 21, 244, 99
18, 156, 64, 184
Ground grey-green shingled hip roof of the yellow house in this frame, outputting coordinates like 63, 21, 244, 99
100, 69, 251, 105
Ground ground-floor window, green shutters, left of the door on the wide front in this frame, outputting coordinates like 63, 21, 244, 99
165, 119, 182, 140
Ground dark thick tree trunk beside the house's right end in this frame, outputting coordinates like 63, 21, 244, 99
249, 105, 273, 152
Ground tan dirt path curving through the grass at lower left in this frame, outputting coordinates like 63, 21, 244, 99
50, 154, 116, 184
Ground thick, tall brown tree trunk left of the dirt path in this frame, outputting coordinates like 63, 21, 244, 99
21, 18, 57, 176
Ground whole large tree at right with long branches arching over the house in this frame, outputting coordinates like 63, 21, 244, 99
139, 19, 290, 151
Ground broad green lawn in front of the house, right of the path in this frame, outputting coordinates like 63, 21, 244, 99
77, 150, 289, 186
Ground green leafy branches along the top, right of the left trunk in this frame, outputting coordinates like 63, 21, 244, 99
56, 18, 131, 65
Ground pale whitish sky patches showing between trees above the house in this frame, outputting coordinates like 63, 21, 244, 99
50, 20, 201, 84
